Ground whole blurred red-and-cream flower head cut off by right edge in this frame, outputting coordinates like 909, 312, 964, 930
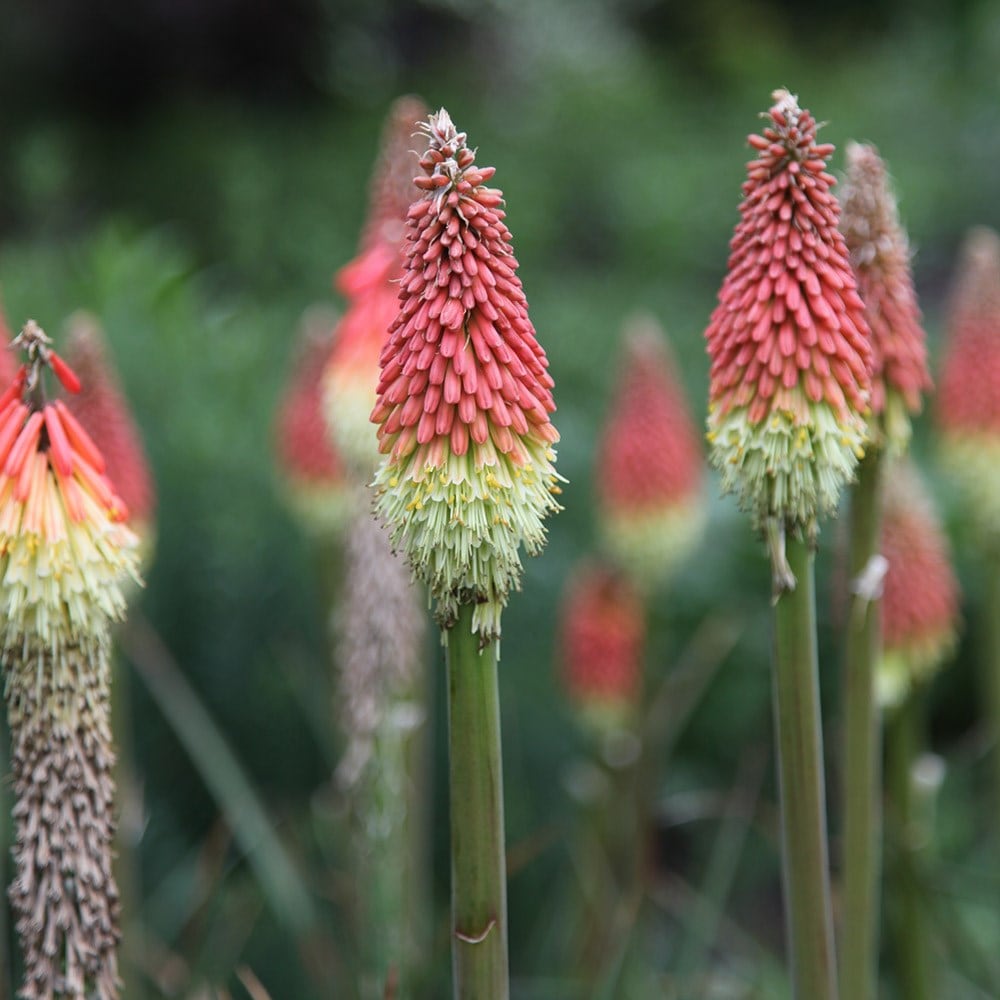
937, 228, 1000, 549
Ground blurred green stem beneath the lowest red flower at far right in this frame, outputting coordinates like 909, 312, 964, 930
886, 691, 937, 1000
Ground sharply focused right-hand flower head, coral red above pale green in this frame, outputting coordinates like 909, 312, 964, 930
705, 90, 871, 525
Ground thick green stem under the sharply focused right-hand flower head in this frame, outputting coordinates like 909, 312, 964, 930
774, 537, 837, 1000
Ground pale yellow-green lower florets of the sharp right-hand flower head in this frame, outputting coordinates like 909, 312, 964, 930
708, 397, 866, 528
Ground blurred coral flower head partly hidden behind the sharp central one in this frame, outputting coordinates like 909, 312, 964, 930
323, 97, 427, 477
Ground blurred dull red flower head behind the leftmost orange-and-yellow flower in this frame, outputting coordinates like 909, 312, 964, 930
66, 313, 156, 537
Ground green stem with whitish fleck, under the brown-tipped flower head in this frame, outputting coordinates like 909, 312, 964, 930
840, 448, 883, 1000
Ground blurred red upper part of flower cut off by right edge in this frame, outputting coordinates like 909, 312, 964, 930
938, 228, 1000, 437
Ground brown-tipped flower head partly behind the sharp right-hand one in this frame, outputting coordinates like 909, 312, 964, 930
841, 143, 931, 454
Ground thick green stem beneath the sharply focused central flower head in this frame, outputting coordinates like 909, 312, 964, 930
447, 604, 509, 1000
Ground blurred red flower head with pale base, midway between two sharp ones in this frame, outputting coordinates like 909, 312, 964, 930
596, 317, 705, 587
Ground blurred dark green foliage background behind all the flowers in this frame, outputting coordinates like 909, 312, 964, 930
0, 0, 1000, 1000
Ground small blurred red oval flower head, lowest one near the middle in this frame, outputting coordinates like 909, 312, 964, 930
559, 563, 646, 726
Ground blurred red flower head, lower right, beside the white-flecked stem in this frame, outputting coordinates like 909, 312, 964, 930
876, 464, 959, 705
